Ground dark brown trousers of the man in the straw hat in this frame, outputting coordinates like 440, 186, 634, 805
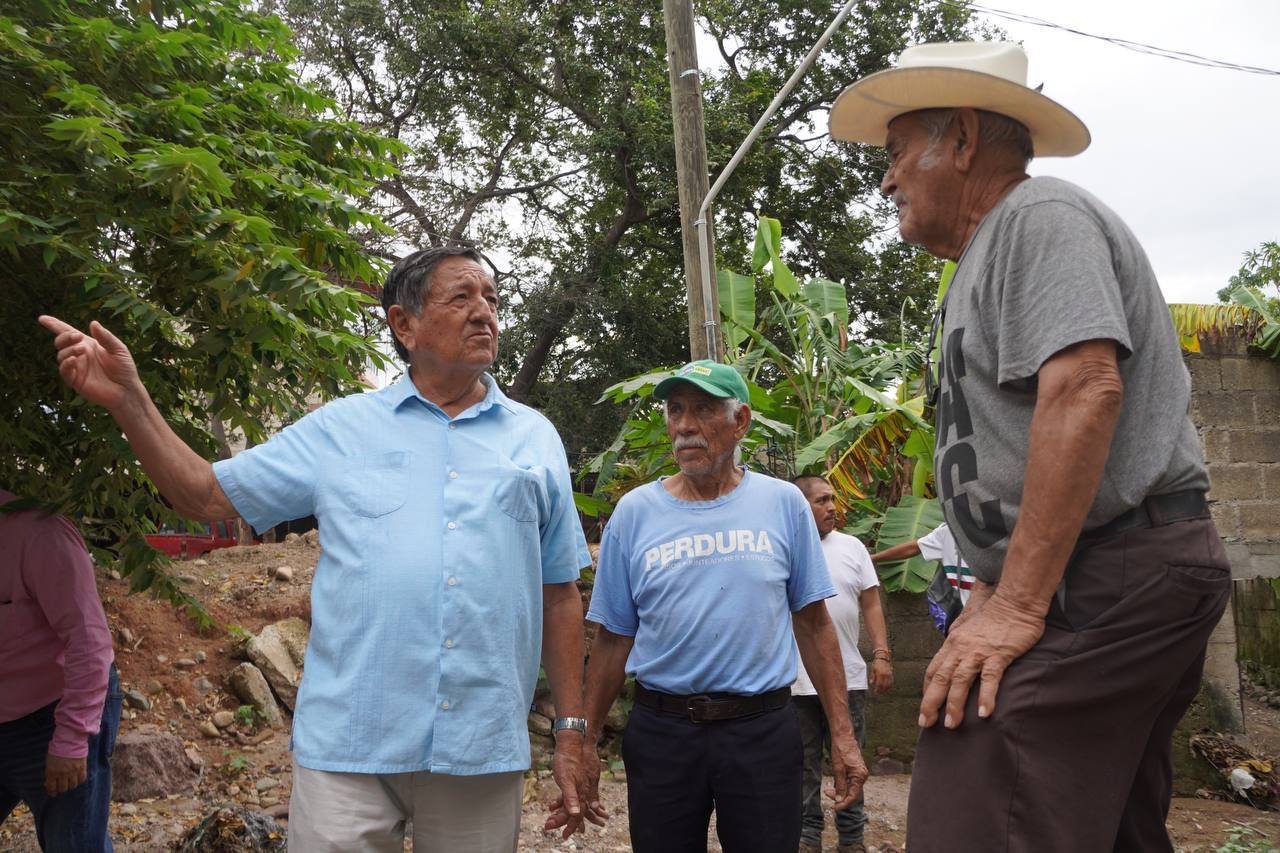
906, 519, 1231, 853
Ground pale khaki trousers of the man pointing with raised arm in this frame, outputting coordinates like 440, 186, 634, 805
289, 761, 525, 853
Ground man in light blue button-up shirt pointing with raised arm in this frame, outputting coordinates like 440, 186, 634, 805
42, 242, 590, 853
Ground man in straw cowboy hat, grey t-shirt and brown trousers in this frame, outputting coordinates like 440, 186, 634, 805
831, 42, 1230, 853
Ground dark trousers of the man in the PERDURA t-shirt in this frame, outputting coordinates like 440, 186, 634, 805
622, 703, 801, 853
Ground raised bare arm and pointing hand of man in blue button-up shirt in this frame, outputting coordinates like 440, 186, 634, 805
40, 315, 237, 521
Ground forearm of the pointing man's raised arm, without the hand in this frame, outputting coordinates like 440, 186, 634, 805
111, 383, 237, 521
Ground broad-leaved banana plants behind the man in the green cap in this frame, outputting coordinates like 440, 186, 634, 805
579, 216, 955, 592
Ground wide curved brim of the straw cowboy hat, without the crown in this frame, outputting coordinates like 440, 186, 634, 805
831, 67, 1091, 158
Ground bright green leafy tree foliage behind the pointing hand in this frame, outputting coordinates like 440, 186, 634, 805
0, 0, 398, 612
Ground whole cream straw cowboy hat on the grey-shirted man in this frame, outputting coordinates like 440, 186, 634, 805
831, 41, 1089, 158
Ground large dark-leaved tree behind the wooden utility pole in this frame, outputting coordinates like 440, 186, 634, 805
267, 0, 969, 455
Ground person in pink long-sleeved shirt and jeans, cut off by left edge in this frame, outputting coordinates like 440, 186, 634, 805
0, 489, 120, 853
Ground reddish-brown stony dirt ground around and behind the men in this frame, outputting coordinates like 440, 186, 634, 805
0, 543, 1280, 853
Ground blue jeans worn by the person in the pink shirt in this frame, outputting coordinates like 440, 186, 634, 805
0, 665, 122, 853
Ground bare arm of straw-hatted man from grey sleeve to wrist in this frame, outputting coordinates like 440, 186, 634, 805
996, 342, 1123, 616
